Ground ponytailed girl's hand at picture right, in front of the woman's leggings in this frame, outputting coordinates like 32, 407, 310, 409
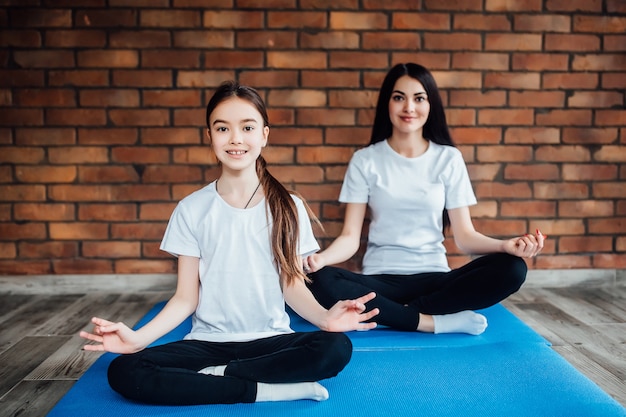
325, 292, 379, 332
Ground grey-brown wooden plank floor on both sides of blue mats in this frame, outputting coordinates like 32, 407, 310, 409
0, 286, 626, 417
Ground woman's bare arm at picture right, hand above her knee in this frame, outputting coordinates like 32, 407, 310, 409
448, 207, 546, 258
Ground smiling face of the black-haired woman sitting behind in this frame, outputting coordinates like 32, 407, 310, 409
389, 75, 430, 133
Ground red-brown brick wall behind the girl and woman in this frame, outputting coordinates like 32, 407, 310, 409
0, 0, 626, 274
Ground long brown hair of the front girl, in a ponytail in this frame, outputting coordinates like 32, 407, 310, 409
206, 81, 319, 285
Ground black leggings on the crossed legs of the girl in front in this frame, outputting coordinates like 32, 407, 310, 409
108, 331, 352, 405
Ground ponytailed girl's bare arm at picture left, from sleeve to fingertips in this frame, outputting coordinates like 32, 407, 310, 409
80, 256, 200, 353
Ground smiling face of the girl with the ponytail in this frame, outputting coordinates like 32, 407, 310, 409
207, 97, 270, 171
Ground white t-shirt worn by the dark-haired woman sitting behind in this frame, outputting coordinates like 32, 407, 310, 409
339, 140, 476, 275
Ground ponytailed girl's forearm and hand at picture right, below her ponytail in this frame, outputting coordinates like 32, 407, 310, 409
283, 272, 378, 332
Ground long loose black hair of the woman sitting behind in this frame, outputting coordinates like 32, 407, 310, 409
370, 62, 455, 229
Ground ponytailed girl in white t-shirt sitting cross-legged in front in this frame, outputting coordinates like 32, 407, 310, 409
81, 82, 377, 405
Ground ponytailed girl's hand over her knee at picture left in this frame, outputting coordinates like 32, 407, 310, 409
80, 317, 145, 353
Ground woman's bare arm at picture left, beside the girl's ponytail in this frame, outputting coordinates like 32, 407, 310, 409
304, 203, 367, 272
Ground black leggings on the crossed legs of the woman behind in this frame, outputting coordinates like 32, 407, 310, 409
309, 253, 528, 330
